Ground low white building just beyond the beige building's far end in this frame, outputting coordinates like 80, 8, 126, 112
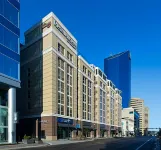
122, 107, 139, 136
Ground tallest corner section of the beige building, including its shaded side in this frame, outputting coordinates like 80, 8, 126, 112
18, 12, 80, 140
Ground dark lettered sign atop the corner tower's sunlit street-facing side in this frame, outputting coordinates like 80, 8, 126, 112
54, 20, 77, 50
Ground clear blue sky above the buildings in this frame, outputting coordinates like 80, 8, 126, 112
21, 0, 161, 127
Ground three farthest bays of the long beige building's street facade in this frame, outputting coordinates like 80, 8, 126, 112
91, 65, 122, 137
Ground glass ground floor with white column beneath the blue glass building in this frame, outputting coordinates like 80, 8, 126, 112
0, 88, 17, 143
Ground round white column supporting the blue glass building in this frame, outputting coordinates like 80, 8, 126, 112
8, 88, 16, 143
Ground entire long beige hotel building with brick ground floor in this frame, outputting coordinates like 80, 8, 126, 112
17, 12, 122, 140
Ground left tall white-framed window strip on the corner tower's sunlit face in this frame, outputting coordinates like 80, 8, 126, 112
58, 58, 64, 115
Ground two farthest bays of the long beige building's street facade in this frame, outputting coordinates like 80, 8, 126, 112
106, 80, 122, 136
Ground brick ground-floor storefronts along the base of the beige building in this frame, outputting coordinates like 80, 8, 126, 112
17, 116, 114, 140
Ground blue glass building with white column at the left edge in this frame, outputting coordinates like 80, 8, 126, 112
0, 0, 20, 143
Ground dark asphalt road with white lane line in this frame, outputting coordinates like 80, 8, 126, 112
18, 137, 155, 150
